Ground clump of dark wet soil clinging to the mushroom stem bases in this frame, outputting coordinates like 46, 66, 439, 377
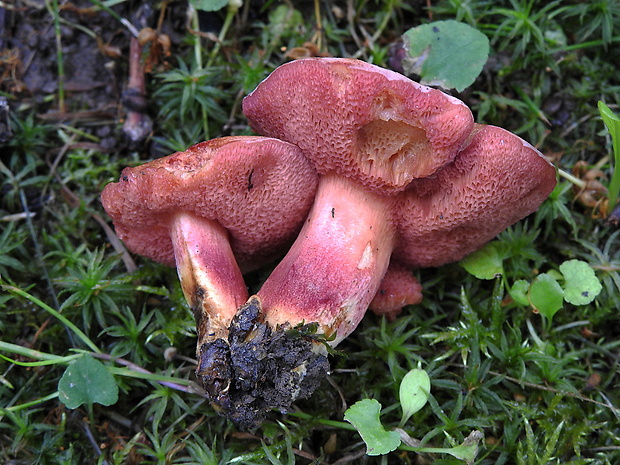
196, 298, 329, 429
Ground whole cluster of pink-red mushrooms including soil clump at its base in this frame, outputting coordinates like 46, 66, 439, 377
102, 58, 556, 428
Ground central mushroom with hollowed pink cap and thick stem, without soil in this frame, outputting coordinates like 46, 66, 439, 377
243, 58, 474, 344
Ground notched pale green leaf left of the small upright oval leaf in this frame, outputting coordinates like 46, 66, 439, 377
344, 399, 400, 455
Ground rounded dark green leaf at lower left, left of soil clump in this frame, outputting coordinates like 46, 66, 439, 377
58, 355, 118, 409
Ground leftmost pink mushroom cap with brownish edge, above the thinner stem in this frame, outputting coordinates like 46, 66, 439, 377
101, 136, 318, 271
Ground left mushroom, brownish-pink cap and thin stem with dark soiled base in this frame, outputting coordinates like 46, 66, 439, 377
101, 136, 317, 399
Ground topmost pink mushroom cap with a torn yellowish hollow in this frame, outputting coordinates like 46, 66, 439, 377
243, 58, 473, 192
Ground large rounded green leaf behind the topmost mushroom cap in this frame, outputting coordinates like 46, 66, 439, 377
403, 20, 489, 92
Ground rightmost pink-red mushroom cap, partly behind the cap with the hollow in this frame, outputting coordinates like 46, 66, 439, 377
393, 125, 556, 267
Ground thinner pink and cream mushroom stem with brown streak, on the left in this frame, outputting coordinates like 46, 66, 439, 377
170, 212, 248, 348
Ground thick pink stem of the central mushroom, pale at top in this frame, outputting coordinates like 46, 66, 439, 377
258, 175, 395, 345
